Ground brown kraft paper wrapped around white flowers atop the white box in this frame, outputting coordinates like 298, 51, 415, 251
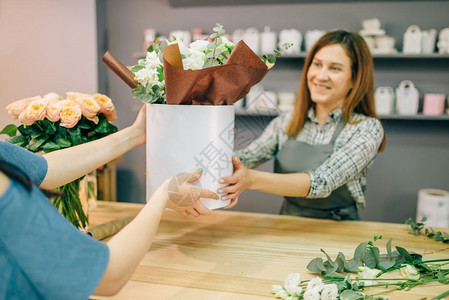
163, 41, 268, 105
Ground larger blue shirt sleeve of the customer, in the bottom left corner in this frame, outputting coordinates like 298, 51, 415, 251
0, 180, 109, 299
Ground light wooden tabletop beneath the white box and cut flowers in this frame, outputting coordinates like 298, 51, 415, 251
89, 201, 449, 300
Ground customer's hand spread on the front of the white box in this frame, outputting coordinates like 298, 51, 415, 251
167, 169, 218, 217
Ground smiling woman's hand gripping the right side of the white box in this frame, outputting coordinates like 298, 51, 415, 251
218, 156, 251, 208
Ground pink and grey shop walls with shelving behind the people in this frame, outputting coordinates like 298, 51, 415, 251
0, 0, 449, 223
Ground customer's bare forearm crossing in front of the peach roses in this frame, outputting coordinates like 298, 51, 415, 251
40, 106, 146, 189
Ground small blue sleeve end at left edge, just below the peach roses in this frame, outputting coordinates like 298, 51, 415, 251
0, 141, 48, 185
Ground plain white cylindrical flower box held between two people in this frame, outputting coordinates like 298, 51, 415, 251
146, 104, 234, 209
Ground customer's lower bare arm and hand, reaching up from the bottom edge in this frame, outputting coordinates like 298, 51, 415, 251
94, 172, 218, 296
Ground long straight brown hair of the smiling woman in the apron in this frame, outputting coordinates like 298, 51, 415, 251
285, 30, 385, 151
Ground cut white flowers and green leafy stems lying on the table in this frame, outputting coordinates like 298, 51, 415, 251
271, 236, 449, 300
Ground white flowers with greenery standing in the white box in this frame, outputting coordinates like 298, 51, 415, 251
130, 24, 291, 103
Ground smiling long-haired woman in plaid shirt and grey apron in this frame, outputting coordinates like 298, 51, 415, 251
221, 30, 385, 220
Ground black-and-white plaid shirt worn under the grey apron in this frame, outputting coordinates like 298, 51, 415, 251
236, 108, 384, 207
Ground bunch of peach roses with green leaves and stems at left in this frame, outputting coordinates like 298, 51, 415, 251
0, 92, 117, 228
